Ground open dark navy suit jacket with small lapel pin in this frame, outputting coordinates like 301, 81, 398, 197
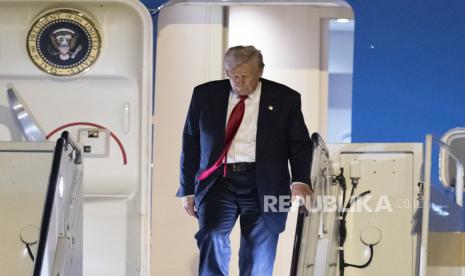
177, 79, 311, 233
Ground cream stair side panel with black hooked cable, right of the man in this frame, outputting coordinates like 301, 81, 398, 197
328, 144, 422, 276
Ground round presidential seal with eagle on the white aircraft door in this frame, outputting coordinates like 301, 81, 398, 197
27, 9, 101, 76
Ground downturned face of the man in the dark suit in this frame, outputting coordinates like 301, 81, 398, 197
226, 60, 263, 95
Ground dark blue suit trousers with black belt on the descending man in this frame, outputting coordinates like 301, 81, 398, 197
195, 170, 278, 276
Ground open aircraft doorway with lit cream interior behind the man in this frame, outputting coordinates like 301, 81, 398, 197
151, 1, 354, 275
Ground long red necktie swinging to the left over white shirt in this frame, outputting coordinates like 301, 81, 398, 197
198, 96, 248, 180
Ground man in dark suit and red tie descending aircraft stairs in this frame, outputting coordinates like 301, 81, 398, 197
177, 46, 312, 276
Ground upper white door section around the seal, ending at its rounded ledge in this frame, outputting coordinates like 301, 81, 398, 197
0, 1, 152, 196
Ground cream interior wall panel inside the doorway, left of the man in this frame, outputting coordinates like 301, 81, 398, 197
151, 5, 223, 276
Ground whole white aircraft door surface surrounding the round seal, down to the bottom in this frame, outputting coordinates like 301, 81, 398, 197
0, 0, 153, 276
